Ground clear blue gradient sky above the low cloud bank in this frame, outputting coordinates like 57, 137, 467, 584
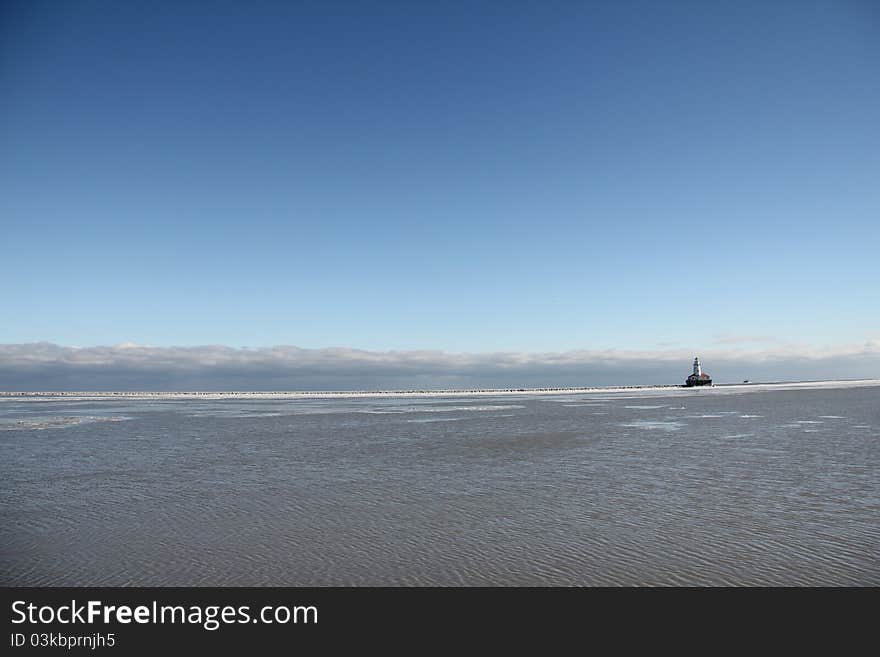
0, 0, 880, 374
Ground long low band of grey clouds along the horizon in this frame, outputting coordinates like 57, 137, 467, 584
0, 339, 880, 391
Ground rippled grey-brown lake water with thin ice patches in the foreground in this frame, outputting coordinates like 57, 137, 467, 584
0, 387, 880, 585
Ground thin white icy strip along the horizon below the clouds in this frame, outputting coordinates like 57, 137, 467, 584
0, 379, 880, 400
